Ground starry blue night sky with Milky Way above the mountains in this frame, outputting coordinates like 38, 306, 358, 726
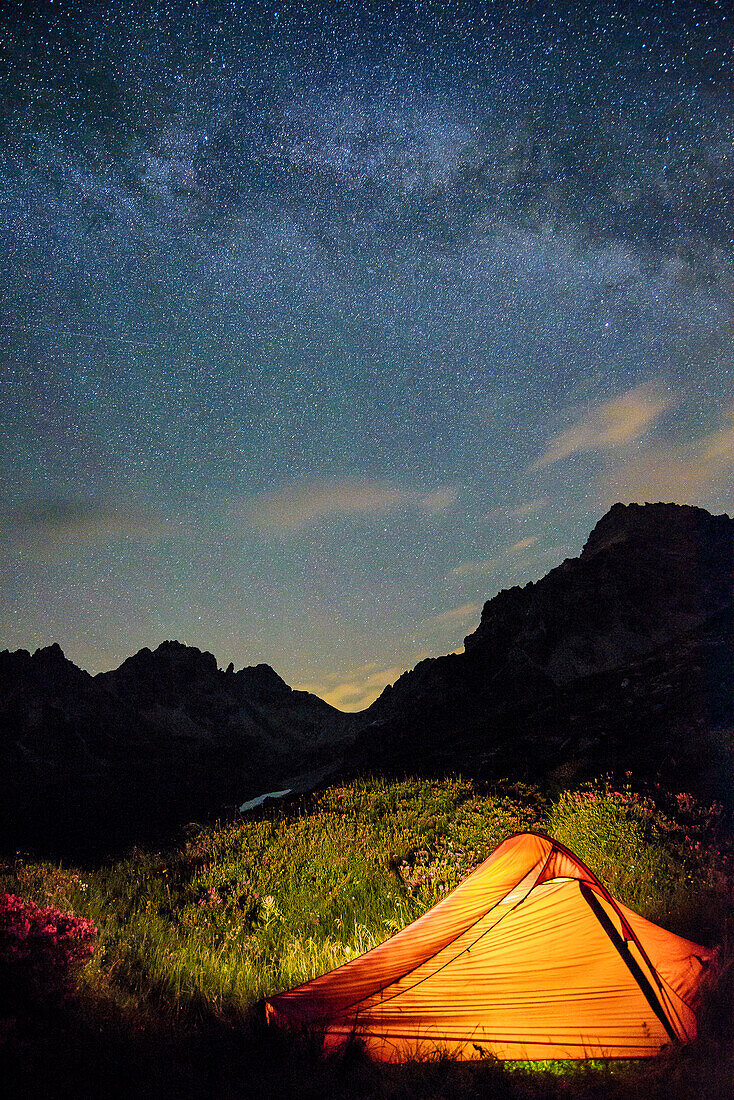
0, 0, 734, 710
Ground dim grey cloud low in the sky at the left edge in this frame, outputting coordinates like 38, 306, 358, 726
0, 498, 169, 551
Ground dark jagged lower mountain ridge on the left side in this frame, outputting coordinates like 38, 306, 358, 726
0, 642, 351, 856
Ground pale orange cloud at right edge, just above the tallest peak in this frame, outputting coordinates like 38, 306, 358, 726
602, 409, 734, 504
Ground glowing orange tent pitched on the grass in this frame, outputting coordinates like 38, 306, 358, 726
266, 833, 716, 1062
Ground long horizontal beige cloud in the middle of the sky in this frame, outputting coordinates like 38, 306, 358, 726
247, 477, 459, 532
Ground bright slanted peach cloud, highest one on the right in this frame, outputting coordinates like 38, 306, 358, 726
530, 383, 672, 472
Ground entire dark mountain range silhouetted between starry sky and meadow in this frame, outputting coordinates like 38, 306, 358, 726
0, 504, 734, 855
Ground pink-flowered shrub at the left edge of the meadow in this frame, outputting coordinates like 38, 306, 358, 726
0, 893, 97, 1011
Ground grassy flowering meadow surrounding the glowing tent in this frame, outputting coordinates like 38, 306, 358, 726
0, 777, 734, 1100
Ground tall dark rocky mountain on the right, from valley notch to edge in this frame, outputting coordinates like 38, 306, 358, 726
357, 504, 734, 788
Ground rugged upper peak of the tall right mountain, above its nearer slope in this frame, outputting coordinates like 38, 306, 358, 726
465, 504, 734, 684
